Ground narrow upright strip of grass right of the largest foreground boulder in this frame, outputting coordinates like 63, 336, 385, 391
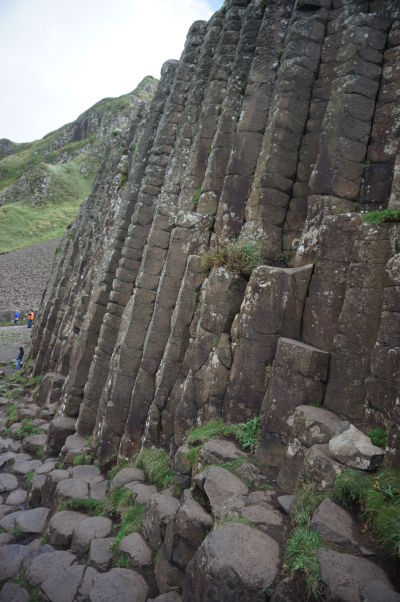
285, 487, 324, 599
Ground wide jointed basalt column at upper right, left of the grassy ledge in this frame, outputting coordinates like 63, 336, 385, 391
310, 13, 389, 201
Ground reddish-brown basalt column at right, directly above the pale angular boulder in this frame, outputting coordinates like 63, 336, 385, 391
324, 224, 390, 424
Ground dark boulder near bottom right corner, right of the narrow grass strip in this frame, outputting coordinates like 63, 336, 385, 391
318, 549, 392, 602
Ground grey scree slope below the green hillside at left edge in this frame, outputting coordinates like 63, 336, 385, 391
0, 240, 59, 321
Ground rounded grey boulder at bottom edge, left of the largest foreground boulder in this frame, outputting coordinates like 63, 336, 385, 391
89, 569, 149, 602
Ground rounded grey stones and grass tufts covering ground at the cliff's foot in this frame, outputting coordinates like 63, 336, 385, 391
0, 346, 400, 602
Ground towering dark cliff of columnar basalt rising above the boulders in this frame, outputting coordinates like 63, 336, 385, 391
5, 0, 400, 600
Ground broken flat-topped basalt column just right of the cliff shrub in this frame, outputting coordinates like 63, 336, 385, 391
223, 265, 312, 422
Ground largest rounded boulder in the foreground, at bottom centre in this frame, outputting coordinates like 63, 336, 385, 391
183, 523, 280, 602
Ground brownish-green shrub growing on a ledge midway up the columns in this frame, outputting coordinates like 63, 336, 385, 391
202, 239, 263, 278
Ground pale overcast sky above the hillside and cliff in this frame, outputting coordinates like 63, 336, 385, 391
0, 0, 223, 142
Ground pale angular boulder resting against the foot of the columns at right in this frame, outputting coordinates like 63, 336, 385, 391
329, 421, 385, 470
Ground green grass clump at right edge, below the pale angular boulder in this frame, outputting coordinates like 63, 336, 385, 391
334, 469, 400, 556
